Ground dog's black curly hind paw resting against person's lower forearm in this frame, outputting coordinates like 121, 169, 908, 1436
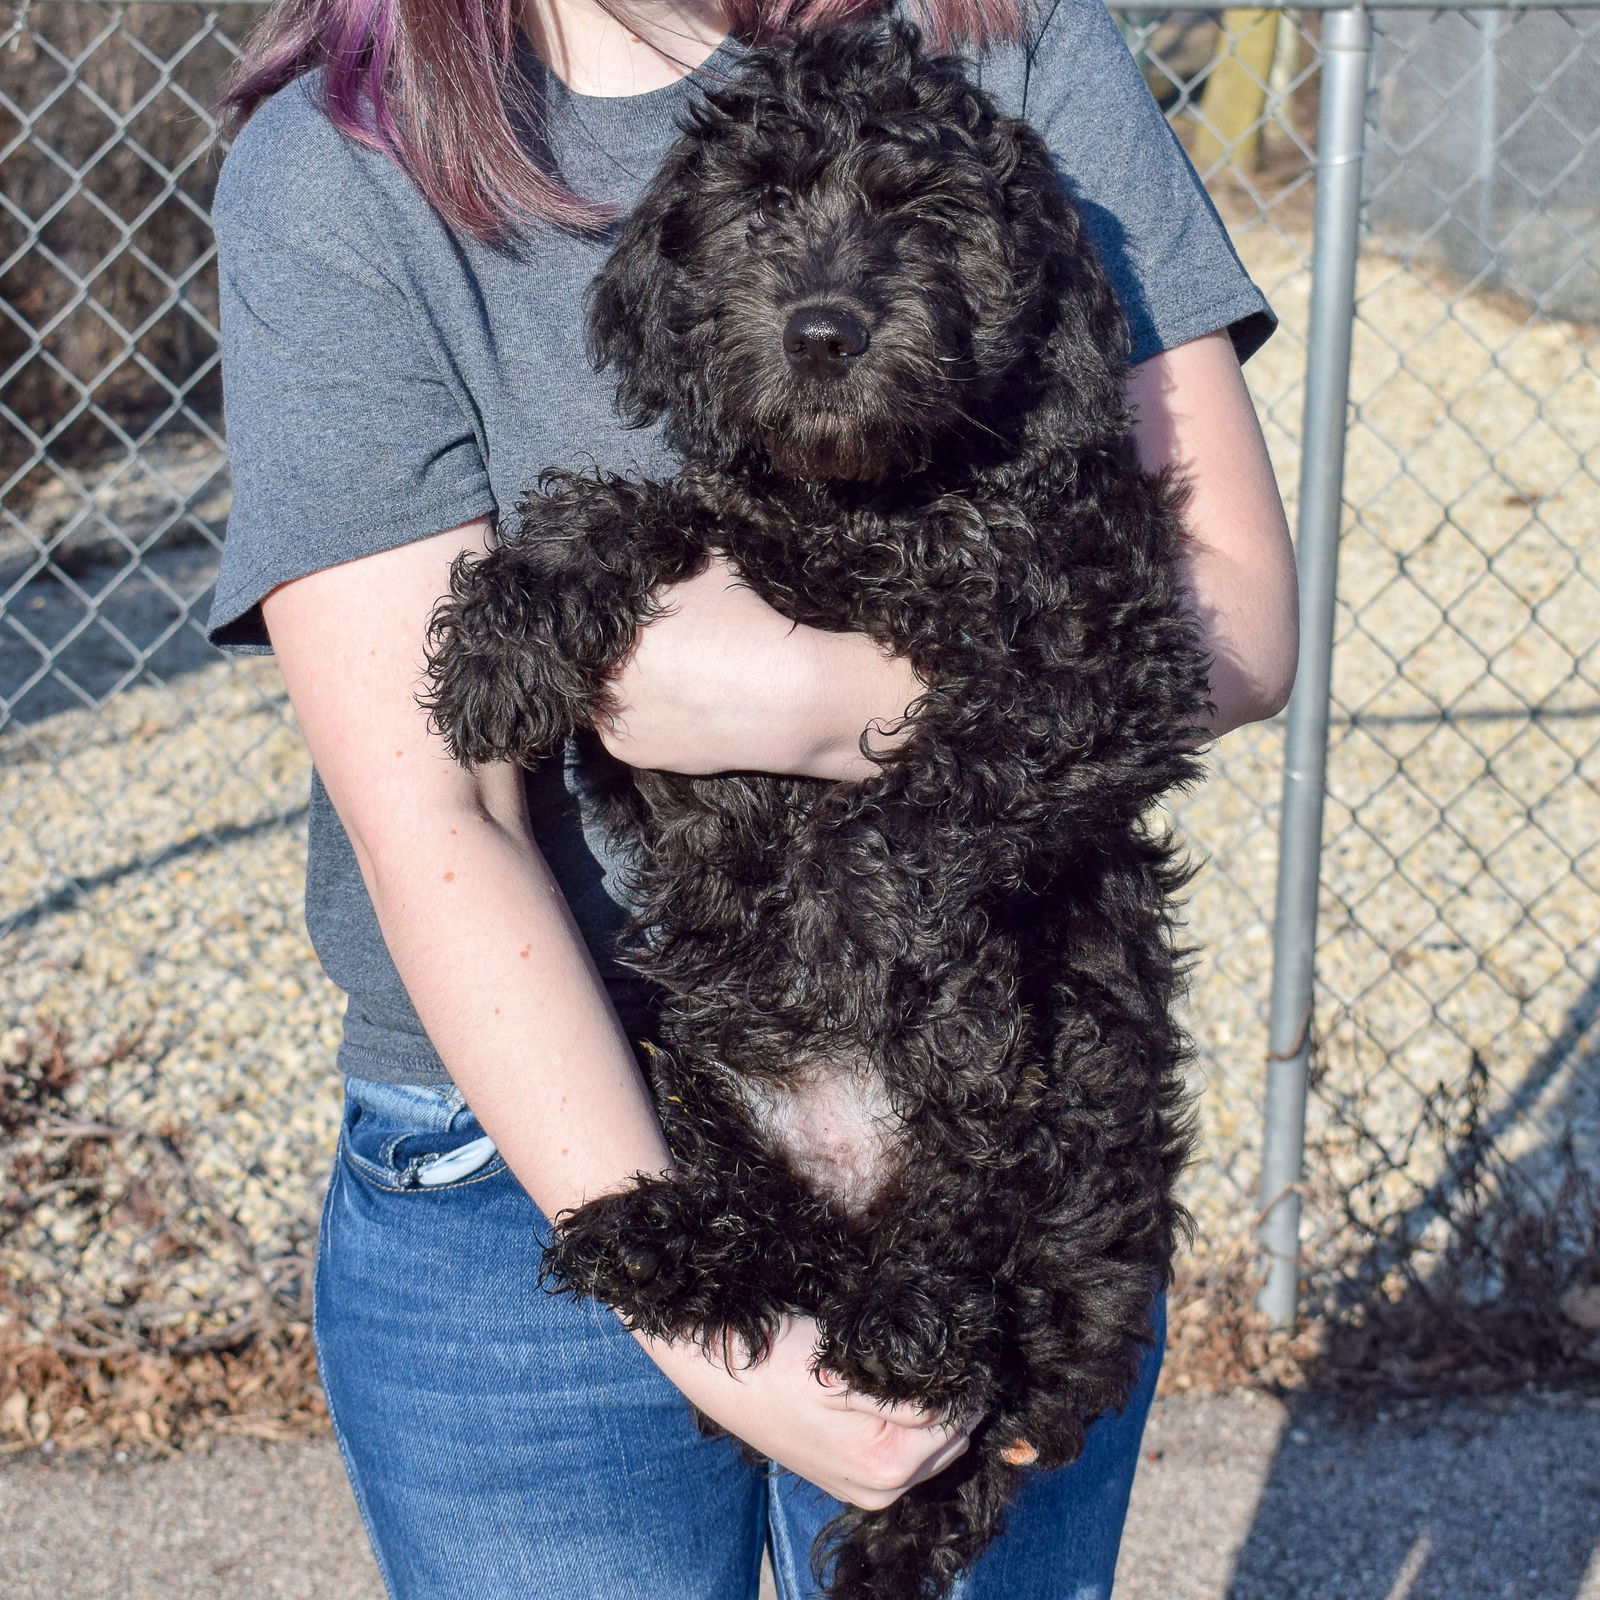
546, 1178, 794, 1354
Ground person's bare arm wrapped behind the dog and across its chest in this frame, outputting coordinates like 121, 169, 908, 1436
600, 324, 1299, 779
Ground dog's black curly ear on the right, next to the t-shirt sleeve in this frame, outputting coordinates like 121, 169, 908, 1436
990, 117, 1130, 450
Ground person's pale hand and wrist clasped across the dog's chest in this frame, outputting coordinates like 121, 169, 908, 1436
598, 560, 923, 781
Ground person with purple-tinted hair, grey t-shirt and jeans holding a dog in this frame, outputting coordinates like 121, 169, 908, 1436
211, 0, 1294, 1600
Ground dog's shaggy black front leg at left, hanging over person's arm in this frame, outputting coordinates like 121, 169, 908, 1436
422, 472, 707, 765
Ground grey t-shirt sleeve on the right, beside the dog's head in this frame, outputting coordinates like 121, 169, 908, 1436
1022, 0, 1277, 363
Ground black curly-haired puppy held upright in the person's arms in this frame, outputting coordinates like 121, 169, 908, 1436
429, 22, 1208, 1600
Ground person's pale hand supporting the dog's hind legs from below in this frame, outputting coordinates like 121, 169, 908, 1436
638, 1317, 973, 1510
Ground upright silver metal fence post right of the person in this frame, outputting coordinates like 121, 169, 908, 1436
1261, 10, 1373, 1328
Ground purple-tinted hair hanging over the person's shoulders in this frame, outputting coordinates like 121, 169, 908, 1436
221, 0, 1026, 240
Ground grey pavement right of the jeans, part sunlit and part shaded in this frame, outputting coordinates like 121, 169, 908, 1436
1117, 1394, 1600, 1600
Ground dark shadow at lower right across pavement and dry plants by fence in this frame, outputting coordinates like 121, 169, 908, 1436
1203, 953, 1600, 1600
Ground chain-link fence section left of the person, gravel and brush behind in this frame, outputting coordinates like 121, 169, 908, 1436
0, 0, 338, 1442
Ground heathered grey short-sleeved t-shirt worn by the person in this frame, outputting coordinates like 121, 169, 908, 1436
210, 0, 1272, 1083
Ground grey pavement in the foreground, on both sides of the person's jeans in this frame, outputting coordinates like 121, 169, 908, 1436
0, 1395, 1600, 1600
